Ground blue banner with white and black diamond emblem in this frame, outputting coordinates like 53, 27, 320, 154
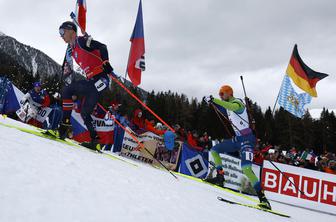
179, 143, 209, 179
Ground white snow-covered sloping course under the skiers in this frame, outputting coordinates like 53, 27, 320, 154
0, 116, 336, 222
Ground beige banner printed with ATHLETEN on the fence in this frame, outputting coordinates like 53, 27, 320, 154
120, 127, 182, 170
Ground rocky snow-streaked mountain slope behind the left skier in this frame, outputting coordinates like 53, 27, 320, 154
0, 32, 61, 78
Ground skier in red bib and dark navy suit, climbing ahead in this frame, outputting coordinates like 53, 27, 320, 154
59, 21, 114, 149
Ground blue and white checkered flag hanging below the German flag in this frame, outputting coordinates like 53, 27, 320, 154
278, 75, 312, 118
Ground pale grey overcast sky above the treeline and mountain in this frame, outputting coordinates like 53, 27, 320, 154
0, 0, 336, 109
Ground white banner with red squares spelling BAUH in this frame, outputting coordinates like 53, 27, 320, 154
262, 161, 336, 215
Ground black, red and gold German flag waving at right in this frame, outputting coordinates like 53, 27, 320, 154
286, 44, 328, 97
